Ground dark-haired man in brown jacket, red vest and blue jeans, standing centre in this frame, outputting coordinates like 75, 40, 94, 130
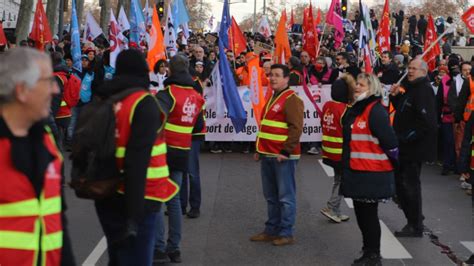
250, 64, 304, 246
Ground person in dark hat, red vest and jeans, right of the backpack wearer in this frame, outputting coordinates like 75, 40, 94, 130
154, 55, 204, 263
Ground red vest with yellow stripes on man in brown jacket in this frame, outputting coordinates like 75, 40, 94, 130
257, 89, 301, 158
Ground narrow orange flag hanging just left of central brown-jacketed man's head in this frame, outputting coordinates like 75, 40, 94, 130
247, 56, 265, 127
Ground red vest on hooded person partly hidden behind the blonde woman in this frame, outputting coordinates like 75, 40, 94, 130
321, 101, 346, 162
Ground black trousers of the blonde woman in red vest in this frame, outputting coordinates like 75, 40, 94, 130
354, 200, 381, 254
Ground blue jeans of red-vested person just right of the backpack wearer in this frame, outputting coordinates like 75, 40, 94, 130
155, 171, 183, 252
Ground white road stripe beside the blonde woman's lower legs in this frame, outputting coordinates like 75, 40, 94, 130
380, 220, 413, 259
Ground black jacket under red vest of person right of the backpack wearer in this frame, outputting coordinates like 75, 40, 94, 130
156, 72, 204, 172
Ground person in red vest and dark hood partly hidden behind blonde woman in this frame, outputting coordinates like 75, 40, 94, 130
321, 74, 356, 223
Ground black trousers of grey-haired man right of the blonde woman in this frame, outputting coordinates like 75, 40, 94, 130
395, 160, 423, 230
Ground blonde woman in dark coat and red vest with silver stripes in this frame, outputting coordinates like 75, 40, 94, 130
341, 73, 398, 265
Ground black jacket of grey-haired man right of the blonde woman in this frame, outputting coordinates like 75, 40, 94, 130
390, 77, 437, 161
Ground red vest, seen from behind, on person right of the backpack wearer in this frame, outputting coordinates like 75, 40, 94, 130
165, 85, 204, 150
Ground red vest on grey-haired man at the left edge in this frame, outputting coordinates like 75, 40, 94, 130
0, 128, 63, 266
